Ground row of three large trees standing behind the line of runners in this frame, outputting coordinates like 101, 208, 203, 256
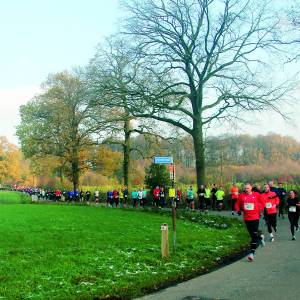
17, 0, 298, 189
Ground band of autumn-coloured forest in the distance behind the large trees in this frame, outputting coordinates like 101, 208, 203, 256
0, 134, 300, 186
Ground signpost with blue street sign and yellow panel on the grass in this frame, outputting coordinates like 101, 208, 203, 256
153, 156, 176, 253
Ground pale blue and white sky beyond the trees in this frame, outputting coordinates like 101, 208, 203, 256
0, 0, 300, 144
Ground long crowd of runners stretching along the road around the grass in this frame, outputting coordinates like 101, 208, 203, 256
14, 181, 300, 261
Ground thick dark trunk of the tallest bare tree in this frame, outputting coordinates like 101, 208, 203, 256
192, 122, 205, 187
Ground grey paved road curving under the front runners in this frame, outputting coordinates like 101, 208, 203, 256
140, 214, 300, 300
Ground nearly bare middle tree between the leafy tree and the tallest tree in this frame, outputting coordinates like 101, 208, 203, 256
86, 37, 173, 186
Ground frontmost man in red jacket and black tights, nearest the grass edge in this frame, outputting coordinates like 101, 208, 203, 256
234, 183, 264, 262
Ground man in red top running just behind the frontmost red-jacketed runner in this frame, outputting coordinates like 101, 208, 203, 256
261, 184, 280, 242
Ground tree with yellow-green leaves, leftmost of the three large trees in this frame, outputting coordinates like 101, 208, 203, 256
17, 72, 108, 189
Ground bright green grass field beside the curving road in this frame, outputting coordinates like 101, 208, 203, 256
0, 193, 249, 299
